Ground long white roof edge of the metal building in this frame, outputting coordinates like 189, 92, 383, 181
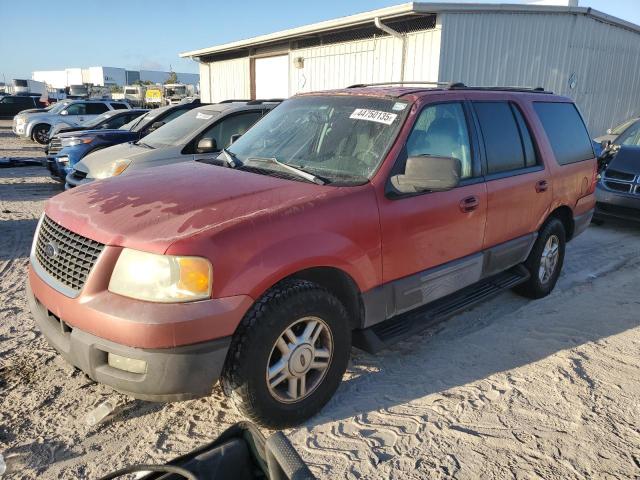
180, 2, 640, 58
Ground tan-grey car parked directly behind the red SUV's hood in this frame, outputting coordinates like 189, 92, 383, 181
66, 100, 279, 188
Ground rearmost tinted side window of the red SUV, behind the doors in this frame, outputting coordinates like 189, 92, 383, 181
533, 102, 595, 165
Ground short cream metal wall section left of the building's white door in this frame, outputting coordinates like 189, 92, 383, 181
209, 57, 251, 102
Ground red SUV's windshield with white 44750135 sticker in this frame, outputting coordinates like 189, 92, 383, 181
229, 95, 407, 181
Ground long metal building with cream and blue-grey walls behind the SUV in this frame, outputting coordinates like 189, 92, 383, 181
181, 0, 640, 135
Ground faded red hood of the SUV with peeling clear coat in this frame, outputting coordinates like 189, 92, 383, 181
45, 162, 335, 253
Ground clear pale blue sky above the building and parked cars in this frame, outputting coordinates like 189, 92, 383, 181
0, 0, 640, 81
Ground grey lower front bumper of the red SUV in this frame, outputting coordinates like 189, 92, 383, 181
27, 285, 231, 402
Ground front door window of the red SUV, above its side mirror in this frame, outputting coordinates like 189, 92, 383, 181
407, 103, 473, 178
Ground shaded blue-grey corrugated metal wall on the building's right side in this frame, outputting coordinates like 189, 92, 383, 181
440, 13, 640, 136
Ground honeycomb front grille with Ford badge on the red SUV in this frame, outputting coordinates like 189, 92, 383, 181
35, 215, 104, 292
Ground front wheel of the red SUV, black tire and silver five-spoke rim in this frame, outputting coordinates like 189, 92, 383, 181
221, 280, 351, 429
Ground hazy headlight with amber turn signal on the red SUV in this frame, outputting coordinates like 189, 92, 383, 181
109, 248, 212, 303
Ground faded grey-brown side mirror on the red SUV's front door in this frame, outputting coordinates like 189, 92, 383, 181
391, 155, 462, 193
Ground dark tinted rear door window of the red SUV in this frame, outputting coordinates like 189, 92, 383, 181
473, 102, 537, 174
